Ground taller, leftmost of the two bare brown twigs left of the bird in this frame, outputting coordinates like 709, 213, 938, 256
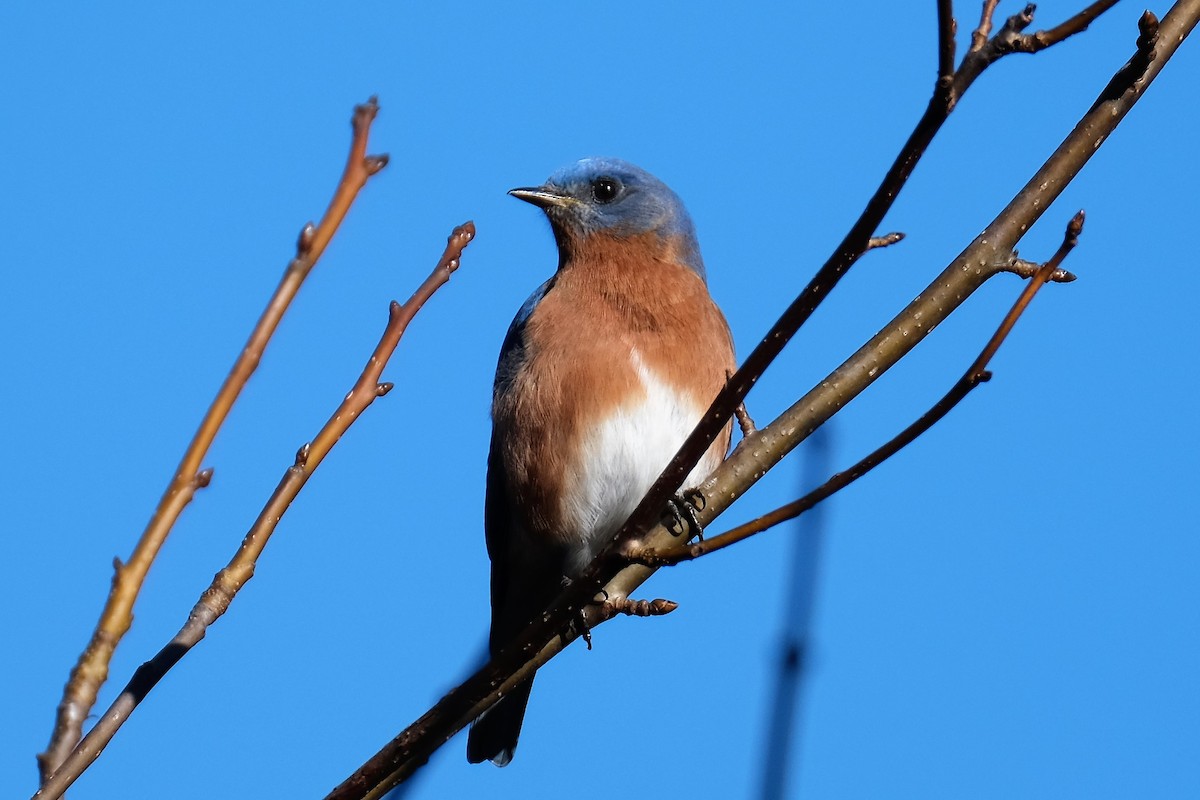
37, 97, 388, 783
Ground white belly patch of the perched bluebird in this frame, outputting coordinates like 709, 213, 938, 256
563, 350, 721, 576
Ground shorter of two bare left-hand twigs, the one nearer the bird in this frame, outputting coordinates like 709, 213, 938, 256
34, 222, 475, 800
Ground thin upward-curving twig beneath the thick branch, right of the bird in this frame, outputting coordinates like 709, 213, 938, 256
628, 211, 1084, 567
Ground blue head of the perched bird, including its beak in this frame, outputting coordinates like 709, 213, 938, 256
509, 158, 704, 277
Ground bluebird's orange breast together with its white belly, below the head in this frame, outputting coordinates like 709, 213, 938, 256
493, 234, 736, 563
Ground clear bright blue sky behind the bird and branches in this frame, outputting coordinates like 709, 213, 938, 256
0, 2, 1200, 799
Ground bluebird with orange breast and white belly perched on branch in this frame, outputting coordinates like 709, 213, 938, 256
467, 158, 736, 766
